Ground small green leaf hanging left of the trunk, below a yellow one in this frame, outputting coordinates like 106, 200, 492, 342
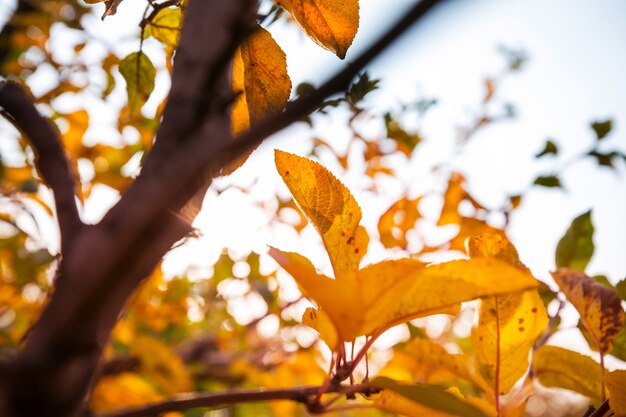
119, 52, 156, 114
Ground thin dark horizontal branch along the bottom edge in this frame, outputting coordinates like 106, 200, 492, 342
98, 384, 378, 417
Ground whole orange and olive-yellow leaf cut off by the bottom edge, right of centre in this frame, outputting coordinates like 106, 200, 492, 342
371, 377, 488, 417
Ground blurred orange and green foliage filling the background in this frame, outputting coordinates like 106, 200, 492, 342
0, 0, 626, 417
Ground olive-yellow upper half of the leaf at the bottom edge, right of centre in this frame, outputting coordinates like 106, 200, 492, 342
371, 377, 486, 417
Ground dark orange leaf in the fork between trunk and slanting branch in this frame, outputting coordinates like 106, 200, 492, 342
225, 26, 291, 173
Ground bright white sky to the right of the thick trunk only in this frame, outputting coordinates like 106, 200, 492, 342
166, 0, 626, 281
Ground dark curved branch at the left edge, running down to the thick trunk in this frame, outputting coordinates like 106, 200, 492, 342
0, 81, 82, 248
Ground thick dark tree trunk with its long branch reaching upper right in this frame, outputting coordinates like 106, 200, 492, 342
6, 0, 444, 417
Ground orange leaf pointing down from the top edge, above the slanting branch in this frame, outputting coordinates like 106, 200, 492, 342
275, 0, 359, 59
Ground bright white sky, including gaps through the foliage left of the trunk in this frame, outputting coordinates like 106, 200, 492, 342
0, 0, 626, 344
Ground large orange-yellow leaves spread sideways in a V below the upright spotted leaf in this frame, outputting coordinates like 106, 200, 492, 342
270, 248, 538, 348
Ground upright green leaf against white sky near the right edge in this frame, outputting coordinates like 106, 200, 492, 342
556, 210, 594, 272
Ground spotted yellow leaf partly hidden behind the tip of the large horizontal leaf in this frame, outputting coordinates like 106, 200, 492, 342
468, 234, 548, 394
